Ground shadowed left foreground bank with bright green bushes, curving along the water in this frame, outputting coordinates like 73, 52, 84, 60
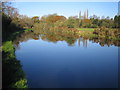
1, 29, 31, 88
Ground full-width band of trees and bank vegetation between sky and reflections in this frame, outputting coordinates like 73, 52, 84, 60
2, 3, 120, 42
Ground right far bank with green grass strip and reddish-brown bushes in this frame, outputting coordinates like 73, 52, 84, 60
77, 27, 120, 40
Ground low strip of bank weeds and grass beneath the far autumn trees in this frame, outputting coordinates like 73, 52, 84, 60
32, 24, 120, 40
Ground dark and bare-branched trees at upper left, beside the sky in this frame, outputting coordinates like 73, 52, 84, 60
1, 2, 33, 42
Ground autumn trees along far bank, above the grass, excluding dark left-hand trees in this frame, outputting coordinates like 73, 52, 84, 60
32, 14, 120, 28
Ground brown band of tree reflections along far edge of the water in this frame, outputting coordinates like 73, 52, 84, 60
13, 31, 120, 49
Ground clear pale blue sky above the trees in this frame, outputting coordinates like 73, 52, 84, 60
13, 2, 118, 18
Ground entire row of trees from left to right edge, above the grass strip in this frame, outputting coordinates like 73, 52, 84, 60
2, 3, 120, 41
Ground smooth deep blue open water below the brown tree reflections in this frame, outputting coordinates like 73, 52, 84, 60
15, 32, 118, 88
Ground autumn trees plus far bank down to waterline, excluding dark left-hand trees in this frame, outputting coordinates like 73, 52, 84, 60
32, 14, 120, 40
